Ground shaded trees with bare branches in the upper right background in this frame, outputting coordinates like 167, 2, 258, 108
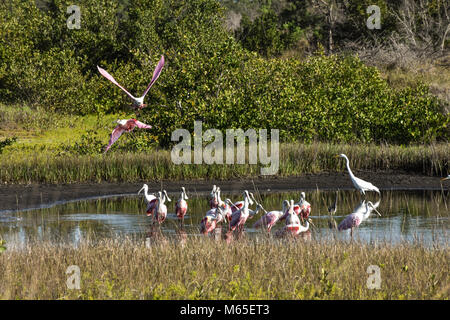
229, 0, 450, 56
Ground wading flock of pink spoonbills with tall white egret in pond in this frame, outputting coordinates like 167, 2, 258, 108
138, 154, 392, 236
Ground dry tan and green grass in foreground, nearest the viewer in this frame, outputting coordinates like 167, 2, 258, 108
0, 238, 450, 299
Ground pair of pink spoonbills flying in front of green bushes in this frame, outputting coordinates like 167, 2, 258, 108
97, 56, 164, 152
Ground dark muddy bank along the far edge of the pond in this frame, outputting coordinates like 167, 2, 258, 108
0, 172, 449, 210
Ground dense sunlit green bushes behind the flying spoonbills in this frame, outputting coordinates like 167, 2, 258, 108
0, 0, 449, 148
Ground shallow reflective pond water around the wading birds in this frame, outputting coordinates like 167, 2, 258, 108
0, 190, 450, 247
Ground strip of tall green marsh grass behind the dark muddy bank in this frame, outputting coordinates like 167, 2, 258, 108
0, 143, 450, 183
